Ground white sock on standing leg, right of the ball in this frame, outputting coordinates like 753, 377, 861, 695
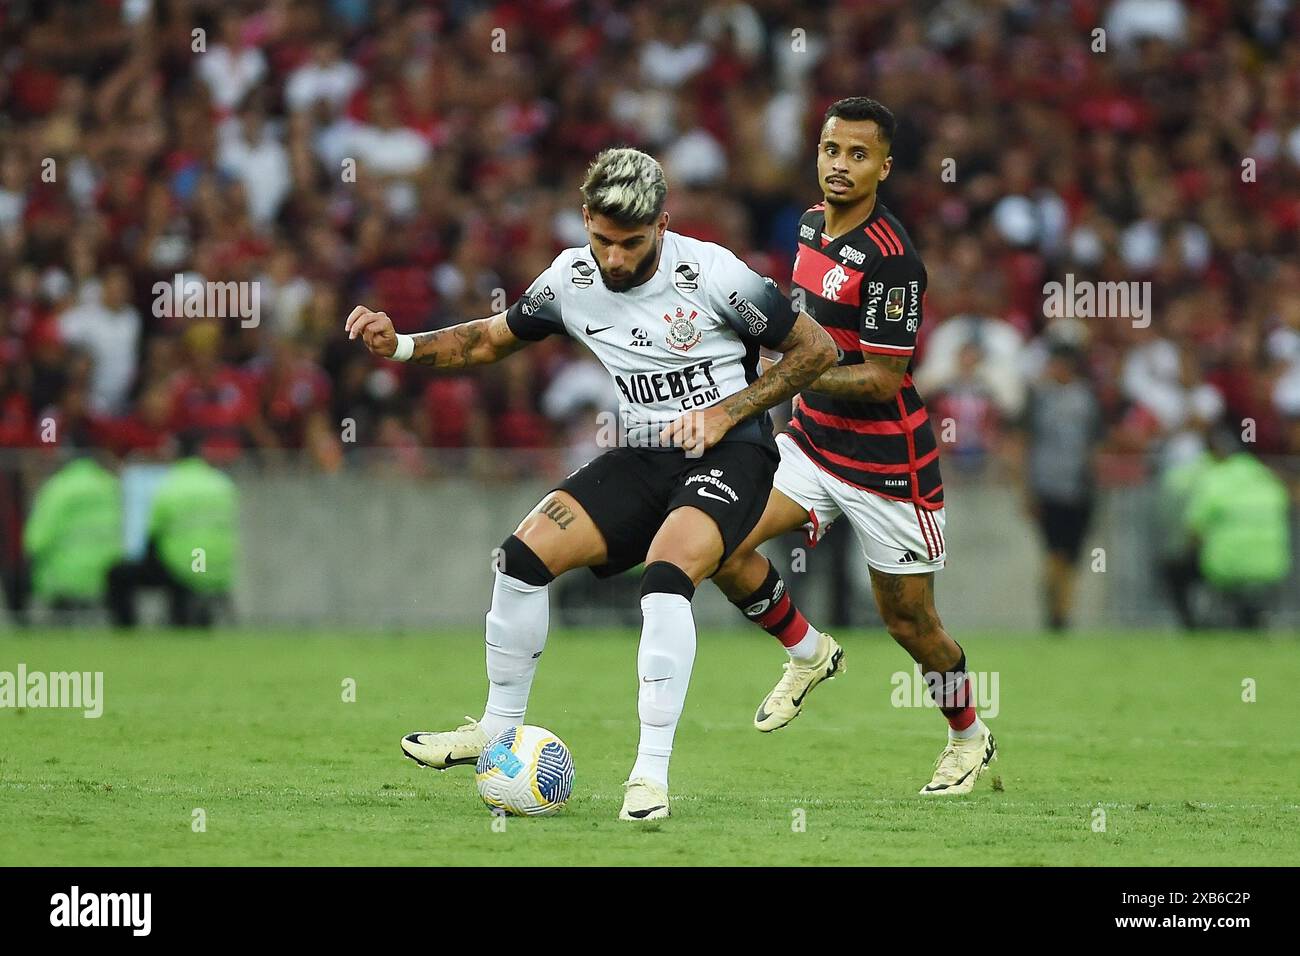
628, 593, 696, 790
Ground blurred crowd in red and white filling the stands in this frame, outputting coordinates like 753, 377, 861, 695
0, 0, 1300, 470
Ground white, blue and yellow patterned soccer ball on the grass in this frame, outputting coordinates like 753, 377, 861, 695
475, 724, 573, 817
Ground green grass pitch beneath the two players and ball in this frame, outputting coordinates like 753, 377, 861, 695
0, 631, 1300, 866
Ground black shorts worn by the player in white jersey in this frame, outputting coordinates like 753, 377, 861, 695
555, 441, 780, 578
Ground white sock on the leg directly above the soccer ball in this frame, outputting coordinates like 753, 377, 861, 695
478, 571, 550, 739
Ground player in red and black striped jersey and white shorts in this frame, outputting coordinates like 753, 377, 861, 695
714, 96, 997, 795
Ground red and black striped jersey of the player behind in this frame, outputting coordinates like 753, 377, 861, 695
789, 199, 944, 511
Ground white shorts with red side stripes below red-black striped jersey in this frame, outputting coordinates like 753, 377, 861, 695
772, 434, 946, 575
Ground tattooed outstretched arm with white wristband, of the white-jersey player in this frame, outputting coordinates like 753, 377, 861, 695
345, 306, 528, 368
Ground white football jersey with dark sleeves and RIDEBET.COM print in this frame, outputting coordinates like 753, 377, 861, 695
506, 232, 797, 446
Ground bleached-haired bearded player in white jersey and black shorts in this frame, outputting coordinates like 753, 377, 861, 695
347, 148, 835, 819
